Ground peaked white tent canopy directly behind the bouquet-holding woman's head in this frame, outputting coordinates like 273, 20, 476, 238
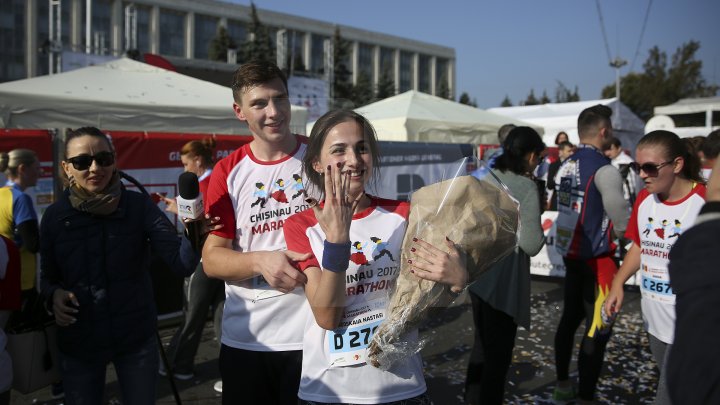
318, 90, 542, 145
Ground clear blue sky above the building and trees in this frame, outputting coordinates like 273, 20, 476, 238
229, 0, 720, 108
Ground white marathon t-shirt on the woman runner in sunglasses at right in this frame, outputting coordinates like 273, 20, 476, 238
625, 184, 705, 344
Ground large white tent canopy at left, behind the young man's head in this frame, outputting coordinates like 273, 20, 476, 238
0, 58, 307, 135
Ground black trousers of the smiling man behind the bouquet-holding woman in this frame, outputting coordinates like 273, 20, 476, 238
220, 345, 302, 405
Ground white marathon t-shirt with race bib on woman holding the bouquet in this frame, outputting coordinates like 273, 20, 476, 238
284, 197, 426, 404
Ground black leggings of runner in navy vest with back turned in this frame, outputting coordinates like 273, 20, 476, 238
555, 258, 611, 401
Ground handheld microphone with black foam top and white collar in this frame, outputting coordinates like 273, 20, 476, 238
176, 172, 205, 253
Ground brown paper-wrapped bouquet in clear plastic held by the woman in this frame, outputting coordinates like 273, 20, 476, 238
367, 159, 519, 370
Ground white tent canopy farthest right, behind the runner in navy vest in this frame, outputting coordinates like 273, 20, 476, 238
488, 98, 645, 152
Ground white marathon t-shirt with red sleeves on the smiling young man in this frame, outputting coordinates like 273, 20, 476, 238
207, 137, 310, 351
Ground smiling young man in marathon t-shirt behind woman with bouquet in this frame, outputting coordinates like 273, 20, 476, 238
203, 62, 309, 404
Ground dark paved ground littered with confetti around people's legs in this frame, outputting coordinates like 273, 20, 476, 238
11, 278, 657, 405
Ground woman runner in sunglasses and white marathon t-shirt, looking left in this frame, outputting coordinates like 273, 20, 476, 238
603, 131, 705, 404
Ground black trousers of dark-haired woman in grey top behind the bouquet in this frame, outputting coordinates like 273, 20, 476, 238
465, 293, 517, 405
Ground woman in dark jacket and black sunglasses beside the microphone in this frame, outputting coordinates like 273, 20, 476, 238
40, 127, 199, 404
